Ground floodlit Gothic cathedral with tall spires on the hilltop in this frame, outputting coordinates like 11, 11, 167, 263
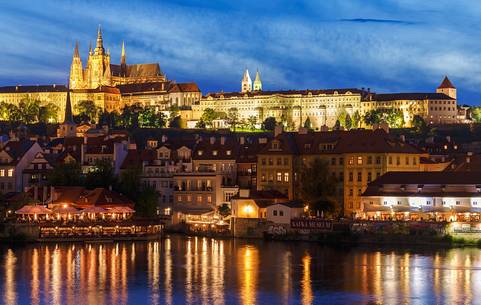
70, 27, 168, 90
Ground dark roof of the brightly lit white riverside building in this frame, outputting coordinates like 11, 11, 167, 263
371, 172, 481, 185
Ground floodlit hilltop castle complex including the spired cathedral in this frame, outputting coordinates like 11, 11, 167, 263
0, 27, 459, 130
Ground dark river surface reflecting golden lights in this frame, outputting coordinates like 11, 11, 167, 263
0, 236, 481, 305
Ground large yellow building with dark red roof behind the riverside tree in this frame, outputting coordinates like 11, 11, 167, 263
257, 129, 428, 217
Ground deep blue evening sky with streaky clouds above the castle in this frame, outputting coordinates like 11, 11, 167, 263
0, 0, 481, 104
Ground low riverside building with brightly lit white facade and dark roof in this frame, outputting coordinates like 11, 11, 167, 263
362, 172, 481, 221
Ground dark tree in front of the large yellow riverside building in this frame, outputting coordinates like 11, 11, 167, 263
299, 158, 339, 213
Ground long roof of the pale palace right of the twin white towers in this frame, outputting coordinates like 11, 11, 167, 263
206, 88, 363, 98
